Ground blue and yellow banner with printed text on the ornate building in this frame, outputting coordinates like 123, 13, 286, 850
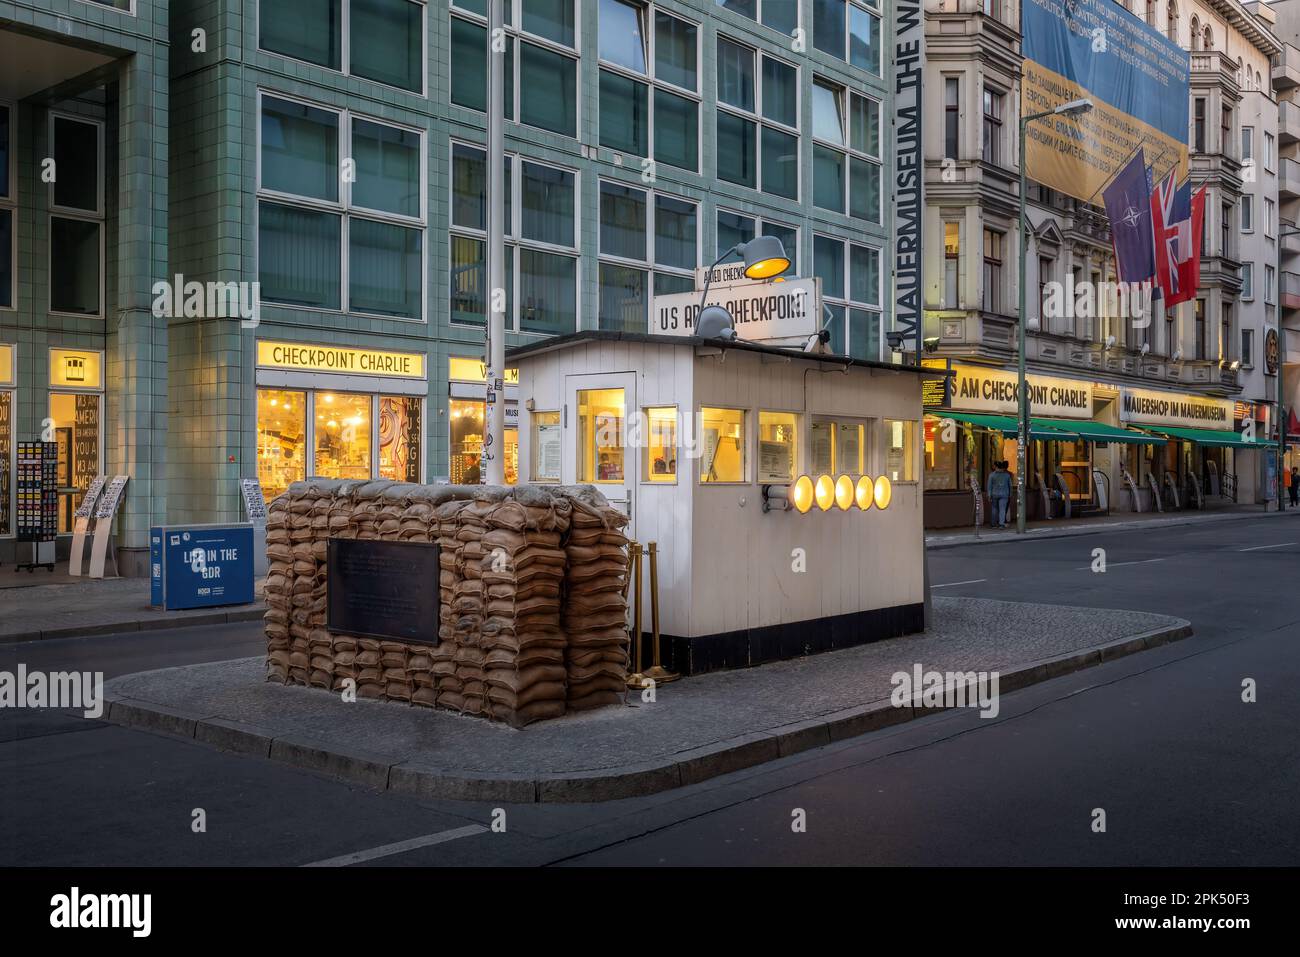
1021, 0, 1191, 203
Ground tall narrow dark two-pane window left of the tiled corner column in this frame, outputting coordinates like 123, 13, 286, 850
48, 113, 104, 316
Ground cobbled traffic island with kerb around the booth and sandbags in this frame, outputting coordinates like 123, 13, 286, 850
105, 598, 1191, 802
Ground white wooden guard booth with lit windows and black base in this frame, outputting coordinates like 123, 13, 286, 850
507, 330, 944, 675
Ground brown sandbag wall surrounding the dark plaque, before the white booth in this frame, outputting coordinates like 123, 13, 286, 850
265, 479, 628, 727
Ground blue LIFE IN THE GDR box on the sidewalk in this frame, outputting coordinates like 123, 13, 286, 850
150, 525, 254, 611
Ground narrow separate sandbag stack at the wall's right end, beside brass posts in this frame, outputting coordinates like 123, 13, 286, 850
563, 494, 628, 711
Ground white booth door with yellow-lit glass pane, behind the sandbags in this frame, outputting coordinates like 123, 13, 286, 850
563, 372, 640, 530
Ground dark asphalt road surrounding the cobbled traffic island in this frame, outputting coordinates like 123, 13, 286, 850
0, 516, 1300, 866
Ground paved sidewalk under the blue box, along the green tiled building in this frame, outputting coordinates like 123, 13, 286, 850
0, 572, 265, 644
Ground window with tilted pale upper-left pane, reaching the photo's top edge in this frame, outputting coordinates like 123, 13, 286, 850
599, 0, 699, 172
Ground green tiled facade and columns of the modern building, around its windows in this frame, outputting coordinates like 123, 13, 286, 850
0, 0, 893, 567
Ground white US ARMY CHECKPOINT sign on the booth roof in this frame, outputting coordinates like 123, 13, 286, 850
650, 280, 820, 341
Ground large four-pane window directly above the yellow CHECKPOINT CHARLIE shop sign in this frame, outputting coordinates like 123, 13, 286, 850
257, 94, 425, 321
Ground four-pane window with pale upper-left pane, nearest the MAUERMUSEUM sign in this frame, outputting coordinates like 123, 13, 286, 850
813, 77, 880, 222
